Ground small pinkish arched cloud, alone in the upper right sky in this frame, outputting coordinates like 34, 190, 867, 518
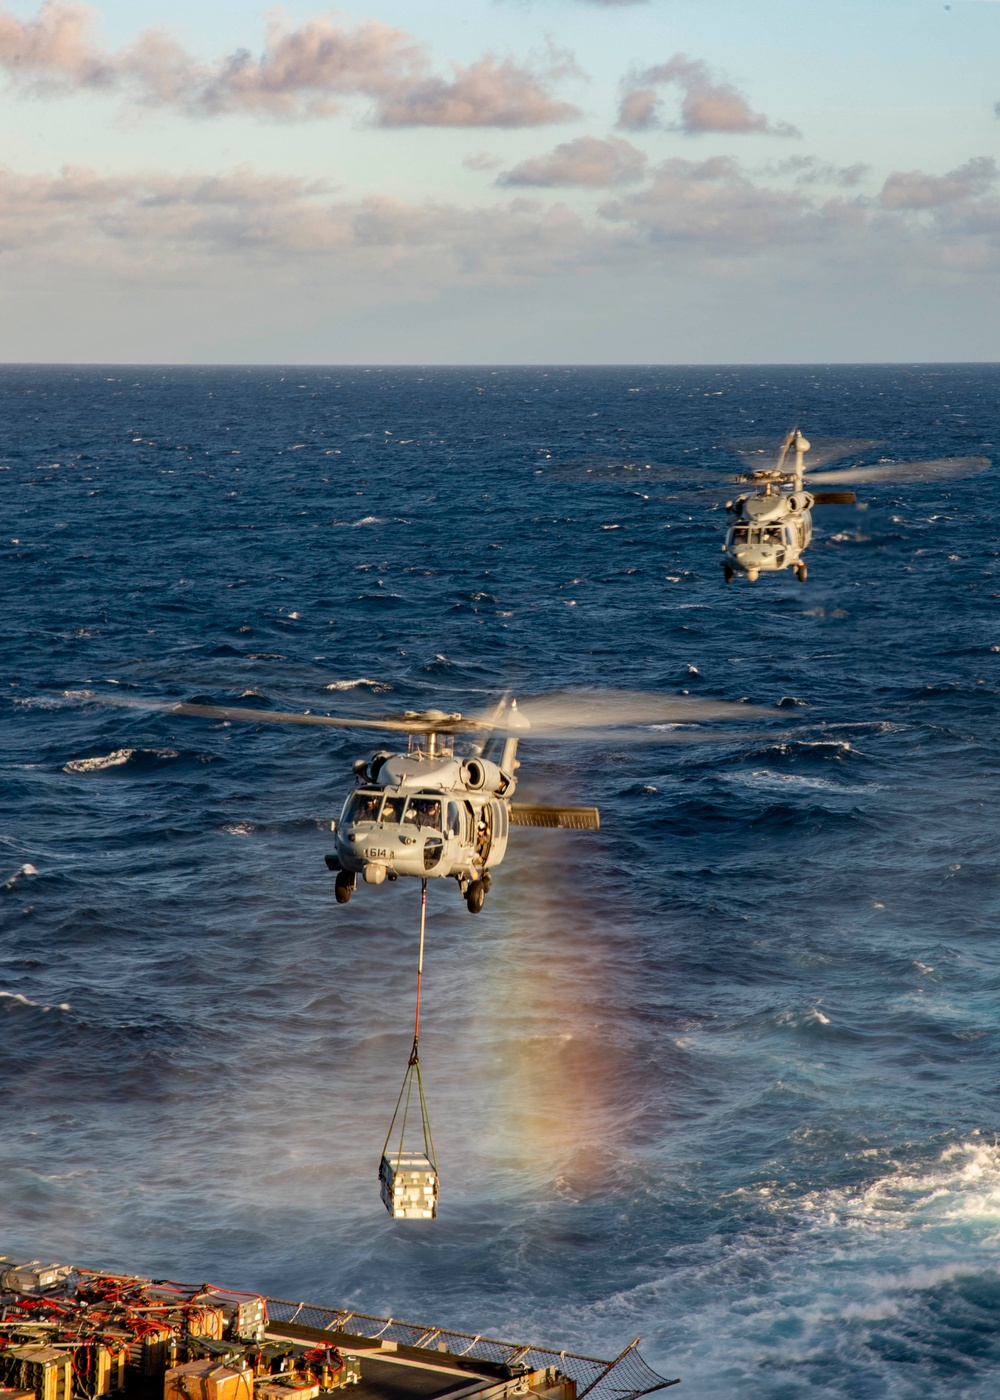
618, 53, 801, 136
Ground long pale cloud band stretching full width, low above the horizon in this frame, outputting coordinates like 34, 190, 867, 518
0, 151, 1000, 298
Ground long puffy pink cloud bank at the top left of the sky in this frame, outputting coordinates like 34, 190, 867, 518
0, 0, 578, 127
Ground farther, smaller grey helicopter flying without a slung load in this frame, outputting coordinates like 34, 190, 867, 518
721, 427, 990, 584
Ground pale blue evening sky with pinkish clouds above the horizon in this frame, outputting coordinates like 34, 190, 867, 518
0, 0, 1000, 364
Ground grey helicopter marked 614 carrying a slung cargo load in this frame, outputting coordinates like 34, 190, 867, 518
101, 690, 773, 914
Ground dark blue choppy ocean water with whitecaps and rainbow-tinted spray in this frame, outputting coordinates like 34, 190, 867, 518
0, 365, 1000, 1400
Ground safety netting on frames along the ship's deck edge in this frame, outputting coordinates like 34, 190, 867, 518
268, 1298, 676, 1400
